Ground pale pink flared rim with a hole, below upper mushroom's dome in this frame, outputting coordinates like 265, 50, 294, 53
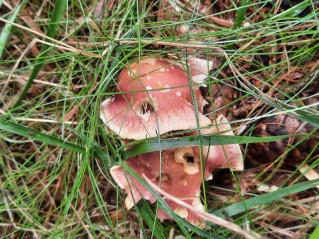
101, 95, 211, 140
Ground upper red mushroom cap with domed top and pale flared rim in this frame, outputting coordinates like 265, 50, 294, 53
101, 58, 211, 140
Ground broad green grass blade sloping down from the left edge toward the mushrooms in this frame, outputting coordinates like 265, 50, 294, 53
0, 119, 86, 154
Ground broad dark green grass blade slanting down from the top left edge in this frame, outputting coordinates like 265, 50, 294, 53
13, 0, 67, 109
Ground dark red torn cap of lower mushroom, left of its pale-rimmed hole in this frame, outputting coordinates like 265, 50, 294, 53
110, 148, 204, 226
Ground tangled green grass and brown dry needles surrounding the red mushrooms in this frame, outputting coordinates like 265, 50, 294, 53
0, 0, 319, 238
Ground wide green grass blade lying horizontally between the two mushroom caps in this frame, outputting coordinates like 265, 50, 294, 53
123, 135, 292, 158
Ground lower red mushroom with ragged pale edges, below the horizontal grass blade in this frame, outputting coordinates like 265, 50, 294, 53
111, 116, 243, 227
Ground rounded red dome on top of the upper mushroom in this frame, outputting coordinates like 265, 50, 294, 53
118, 58, 191, 101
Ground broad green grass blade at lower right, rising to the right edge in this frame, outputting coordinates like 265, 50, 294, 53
214, 179, 319, 217
